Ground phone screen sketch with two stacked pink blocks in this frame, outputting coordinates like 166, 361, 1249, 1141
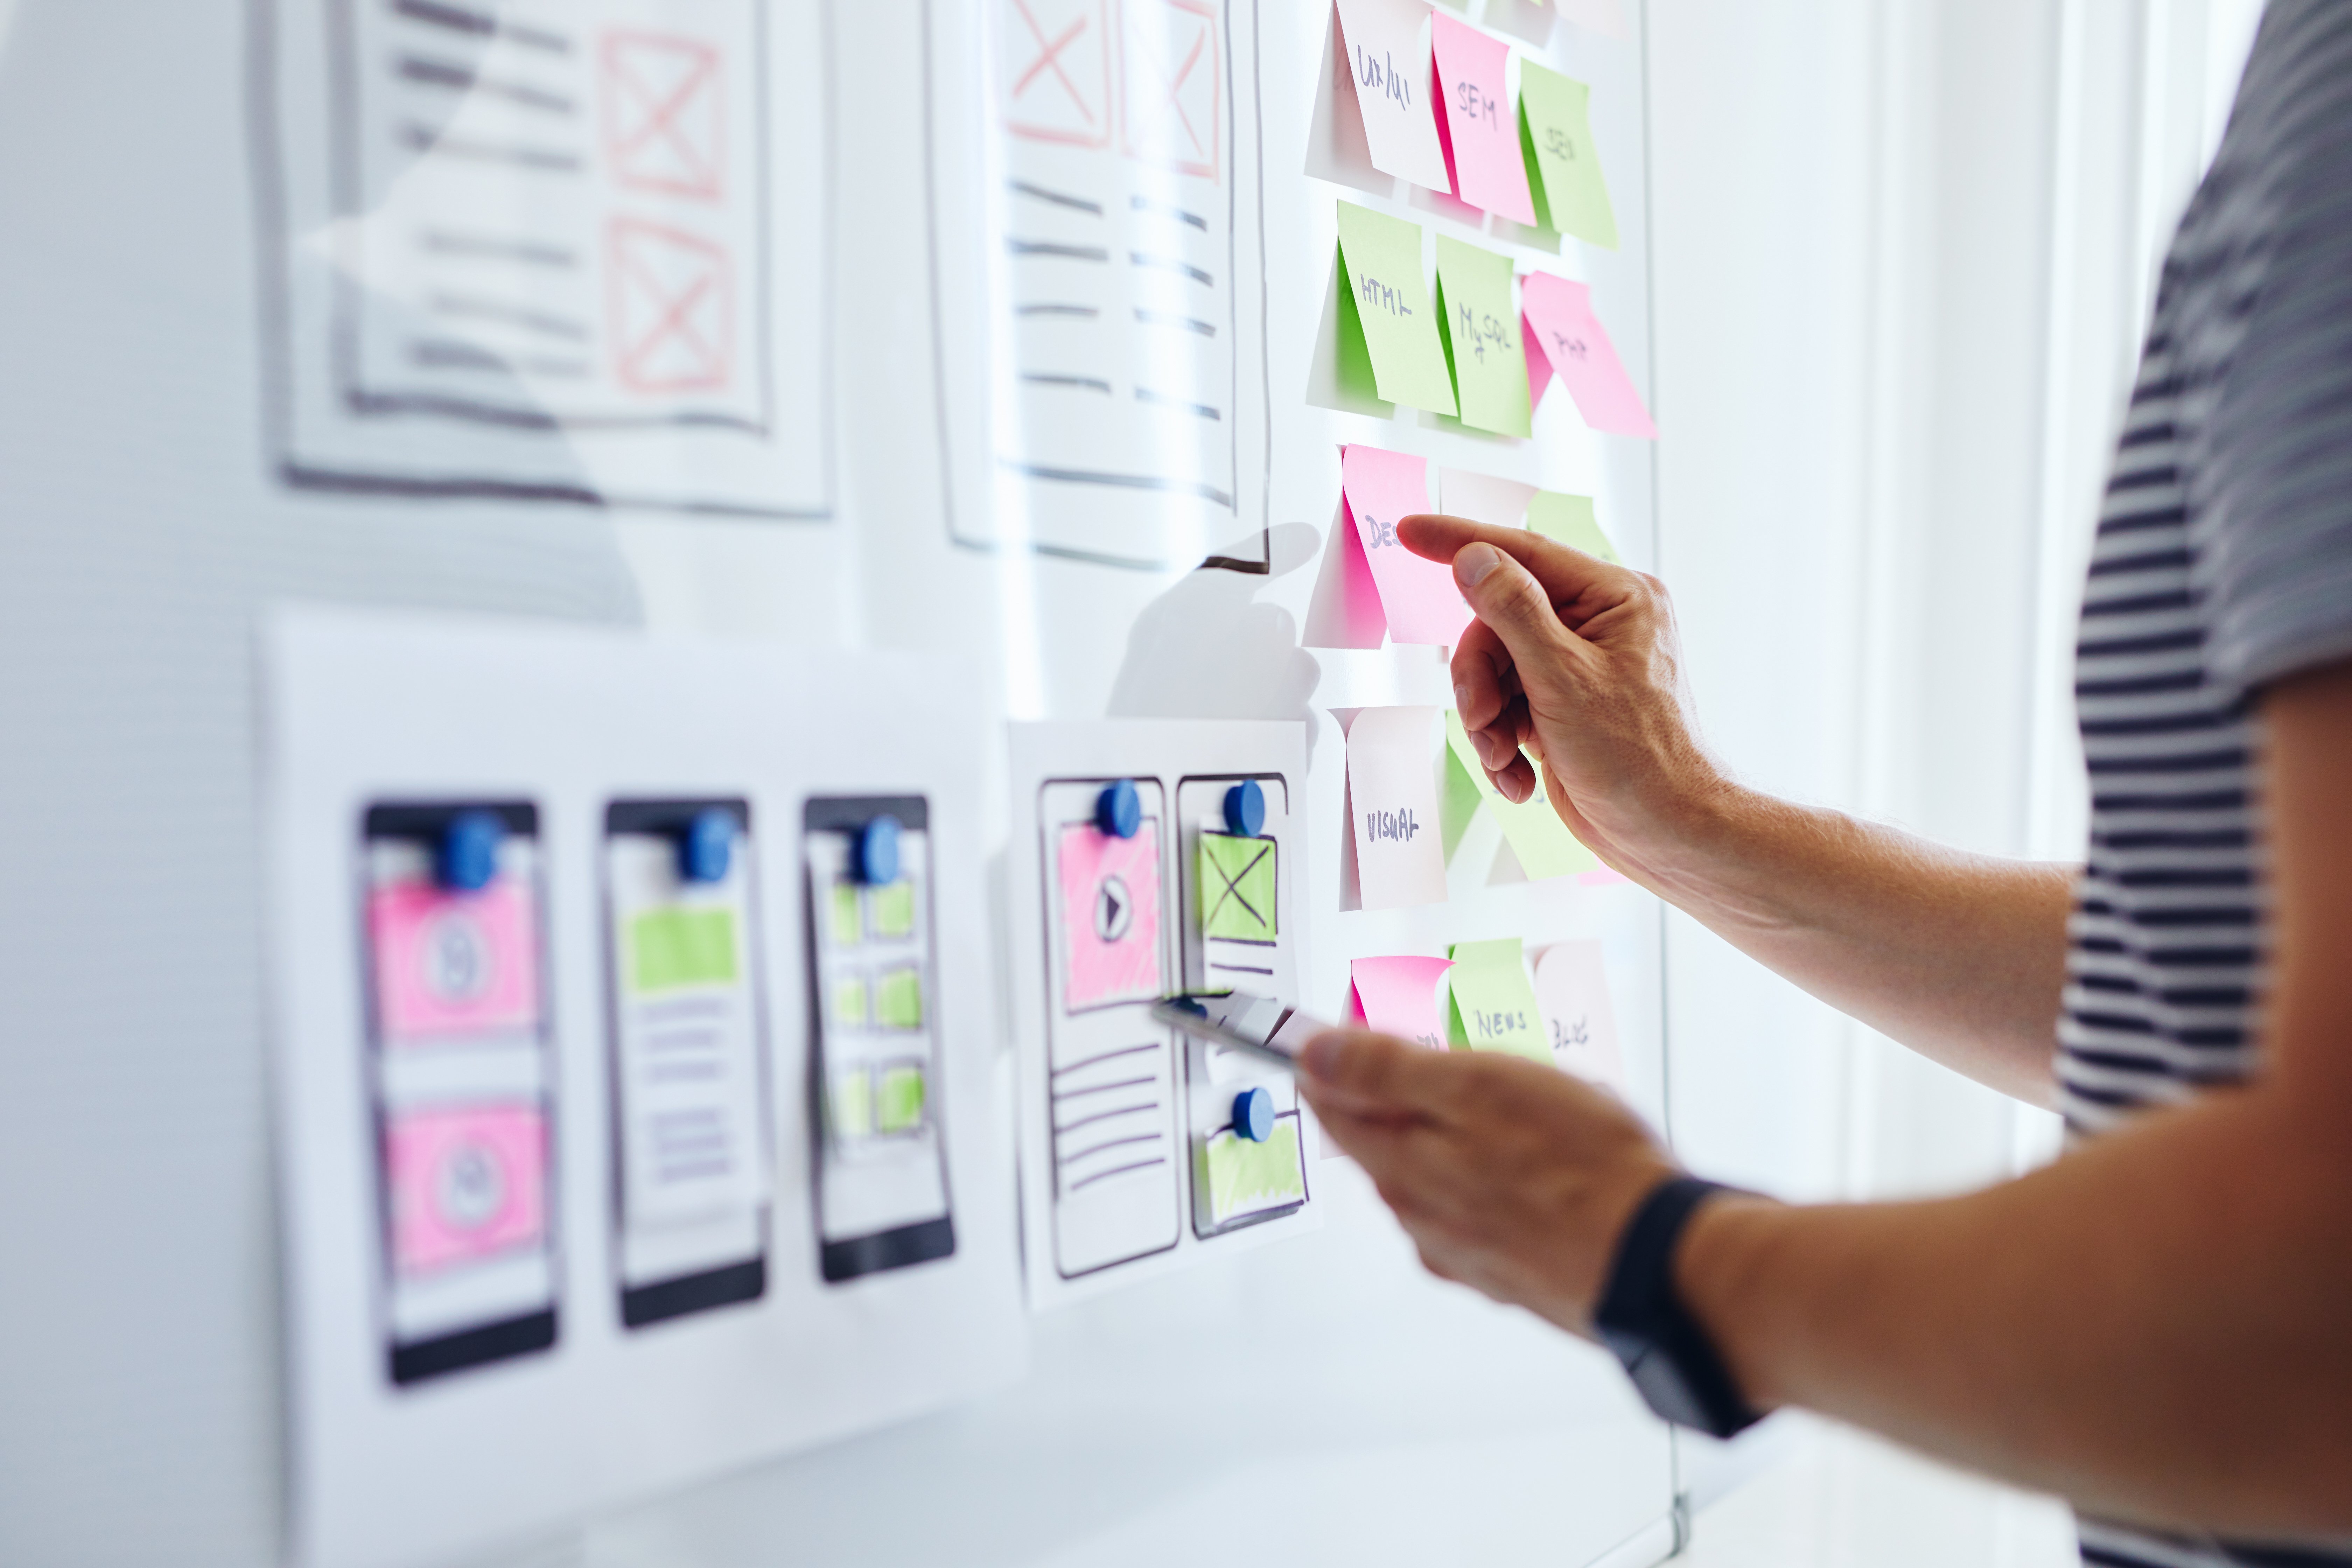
360, 802, 558, 1385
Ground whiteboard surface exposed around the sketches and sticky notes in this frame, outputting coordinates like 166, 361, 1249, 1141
0, 0, 1675, 1566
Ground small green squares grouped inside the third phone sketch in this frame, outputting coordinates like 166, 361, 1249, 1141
826, 877, 929, 1140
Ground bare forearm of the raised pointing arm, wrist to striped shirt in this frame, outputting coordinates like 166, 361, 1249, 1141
1632, 785, 2074, 1102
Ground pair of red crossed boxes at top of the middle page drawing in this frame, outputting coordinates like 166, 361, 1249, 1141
997, 0, 1223, 178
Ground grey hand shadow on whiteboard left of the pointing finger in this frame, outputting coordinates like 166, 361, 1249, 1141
1110, 522, 1322, 752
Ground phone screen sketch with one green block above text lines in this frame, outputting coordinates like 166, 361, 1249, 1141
604, 799, 771, 1328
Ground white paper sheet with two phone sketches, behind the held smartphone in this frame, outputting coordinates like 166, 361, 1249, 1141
1007, 719, 1322, 1307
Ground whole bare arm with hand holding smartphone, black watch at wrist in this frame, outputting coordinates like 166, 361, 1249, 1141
1301, 665, 2352, 1535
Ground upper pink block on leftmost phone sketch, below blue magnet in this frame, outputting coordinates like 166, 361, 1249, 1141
367, 879, 539, 1039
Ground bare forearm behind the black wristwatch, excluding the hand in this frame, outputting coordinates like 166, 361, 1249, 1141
1679, 1096, 2352, 1535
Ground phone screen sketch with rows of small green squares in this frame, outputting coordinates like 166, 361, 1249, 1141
802, 797, 955, 1281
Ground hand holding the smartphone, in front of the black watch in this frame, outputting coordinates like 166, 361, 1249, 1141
1298, 1030, 1677, 1338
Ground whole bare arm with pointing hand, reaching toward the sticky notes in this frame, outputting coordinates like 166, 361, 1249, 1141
1397, 517, 2074, 1102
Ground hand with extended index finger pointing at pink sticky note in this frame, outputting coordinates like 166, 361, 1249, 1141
1397, 517, 1722, 886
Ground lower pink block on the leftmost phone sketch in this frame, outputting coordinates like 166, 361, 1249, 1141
383, 1105, 548, 1274
